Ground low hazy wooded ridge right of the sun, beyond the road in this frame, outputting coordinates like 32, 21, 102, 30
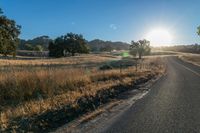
161, 44, 200, 54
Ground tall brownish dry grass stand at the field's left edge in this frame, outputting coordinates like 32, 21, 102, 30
0, 69, 90, 104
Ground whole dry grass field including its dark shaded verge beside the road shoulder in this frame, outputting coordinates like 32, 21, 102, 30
0, 55, 164, 132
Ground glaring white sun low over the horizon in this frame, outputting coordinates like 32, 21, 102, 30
145, 28, 172, 46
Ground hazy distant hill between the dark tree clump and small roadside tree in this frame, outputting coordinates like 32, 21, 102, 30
88, 39, 129, 51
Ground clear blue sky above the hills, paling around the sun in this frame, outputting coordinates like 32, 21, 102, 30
0, 0, 200, 44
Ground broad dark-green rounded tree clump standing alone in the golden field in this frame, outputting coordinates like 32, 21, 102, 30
49, 33, 89, 57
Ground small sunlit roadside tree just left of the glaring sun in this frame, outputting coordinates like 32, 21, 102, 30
130, 39, 151, 59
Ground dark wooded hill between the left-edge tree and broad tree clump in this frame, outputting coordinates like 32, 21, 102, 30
18, 36, 52, 50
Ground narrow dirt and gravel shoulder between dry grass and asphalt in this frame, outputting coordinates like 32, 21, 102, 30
55, 74, 165, 133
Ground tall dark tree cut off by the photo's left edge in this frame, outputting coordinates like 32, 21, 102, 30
0, 9, 21, 56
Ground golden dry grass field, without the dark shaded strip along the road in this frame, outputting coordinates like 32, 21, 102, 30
0, 56, 164, 131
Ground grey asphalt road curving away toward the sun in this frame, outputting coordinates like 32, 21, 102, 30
102, 57, 200, 133
